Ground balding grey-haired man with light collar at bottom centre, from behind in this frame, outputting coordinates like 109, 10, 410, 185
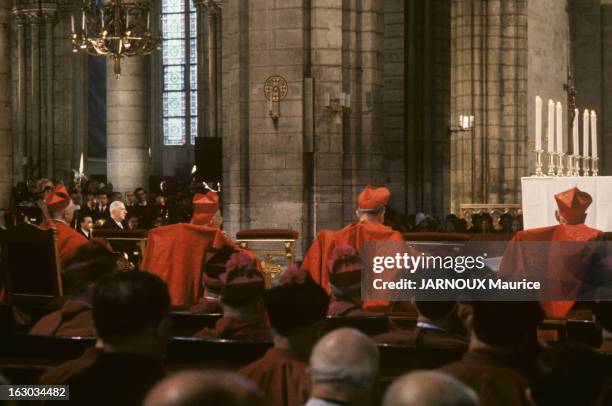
306, 328, 380, 406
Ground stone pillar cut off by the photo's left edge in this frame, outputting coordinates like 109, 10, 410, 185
0, 0, 13, 211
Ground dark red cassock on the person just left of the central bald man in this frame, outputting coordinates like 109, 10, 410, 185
240, 348, 310, 406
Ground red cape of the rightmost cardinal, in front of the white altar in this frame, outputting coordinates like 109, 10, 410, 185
499, 224, 603, 317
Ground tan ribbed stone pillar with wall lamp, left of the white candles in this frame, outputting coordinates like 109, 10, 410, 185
451, 0, 528, 212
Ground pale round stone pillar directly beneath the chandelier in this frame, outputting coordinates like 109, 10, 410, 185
106, 56, 149, 192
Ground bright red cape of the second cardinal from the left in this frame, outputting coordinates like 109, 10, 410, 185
142, 224, 240, 308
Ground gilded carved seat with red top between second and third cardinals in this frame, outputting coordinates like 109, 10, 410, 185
236, 228, 300, 287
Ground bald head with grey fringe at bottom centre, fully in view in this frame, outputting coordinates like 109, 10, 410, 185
310, 328, 379, 387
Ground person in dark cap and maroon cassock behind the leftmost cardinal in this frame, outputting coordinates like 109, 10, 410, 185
30, 238, 117, 337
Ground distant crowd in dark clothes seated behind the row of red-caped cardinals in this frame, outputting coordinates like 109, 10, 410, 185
4, 179, 523, 234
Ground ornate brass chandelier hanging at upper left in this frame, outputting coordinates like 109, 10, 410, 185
71, 0, 162, 79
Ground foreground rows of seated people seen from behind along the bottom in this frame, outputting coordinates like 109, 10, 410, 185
10, 266, 610, 406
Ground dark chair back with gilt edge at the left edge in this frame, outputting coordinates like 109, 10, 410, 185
0, 224, 63, 305
